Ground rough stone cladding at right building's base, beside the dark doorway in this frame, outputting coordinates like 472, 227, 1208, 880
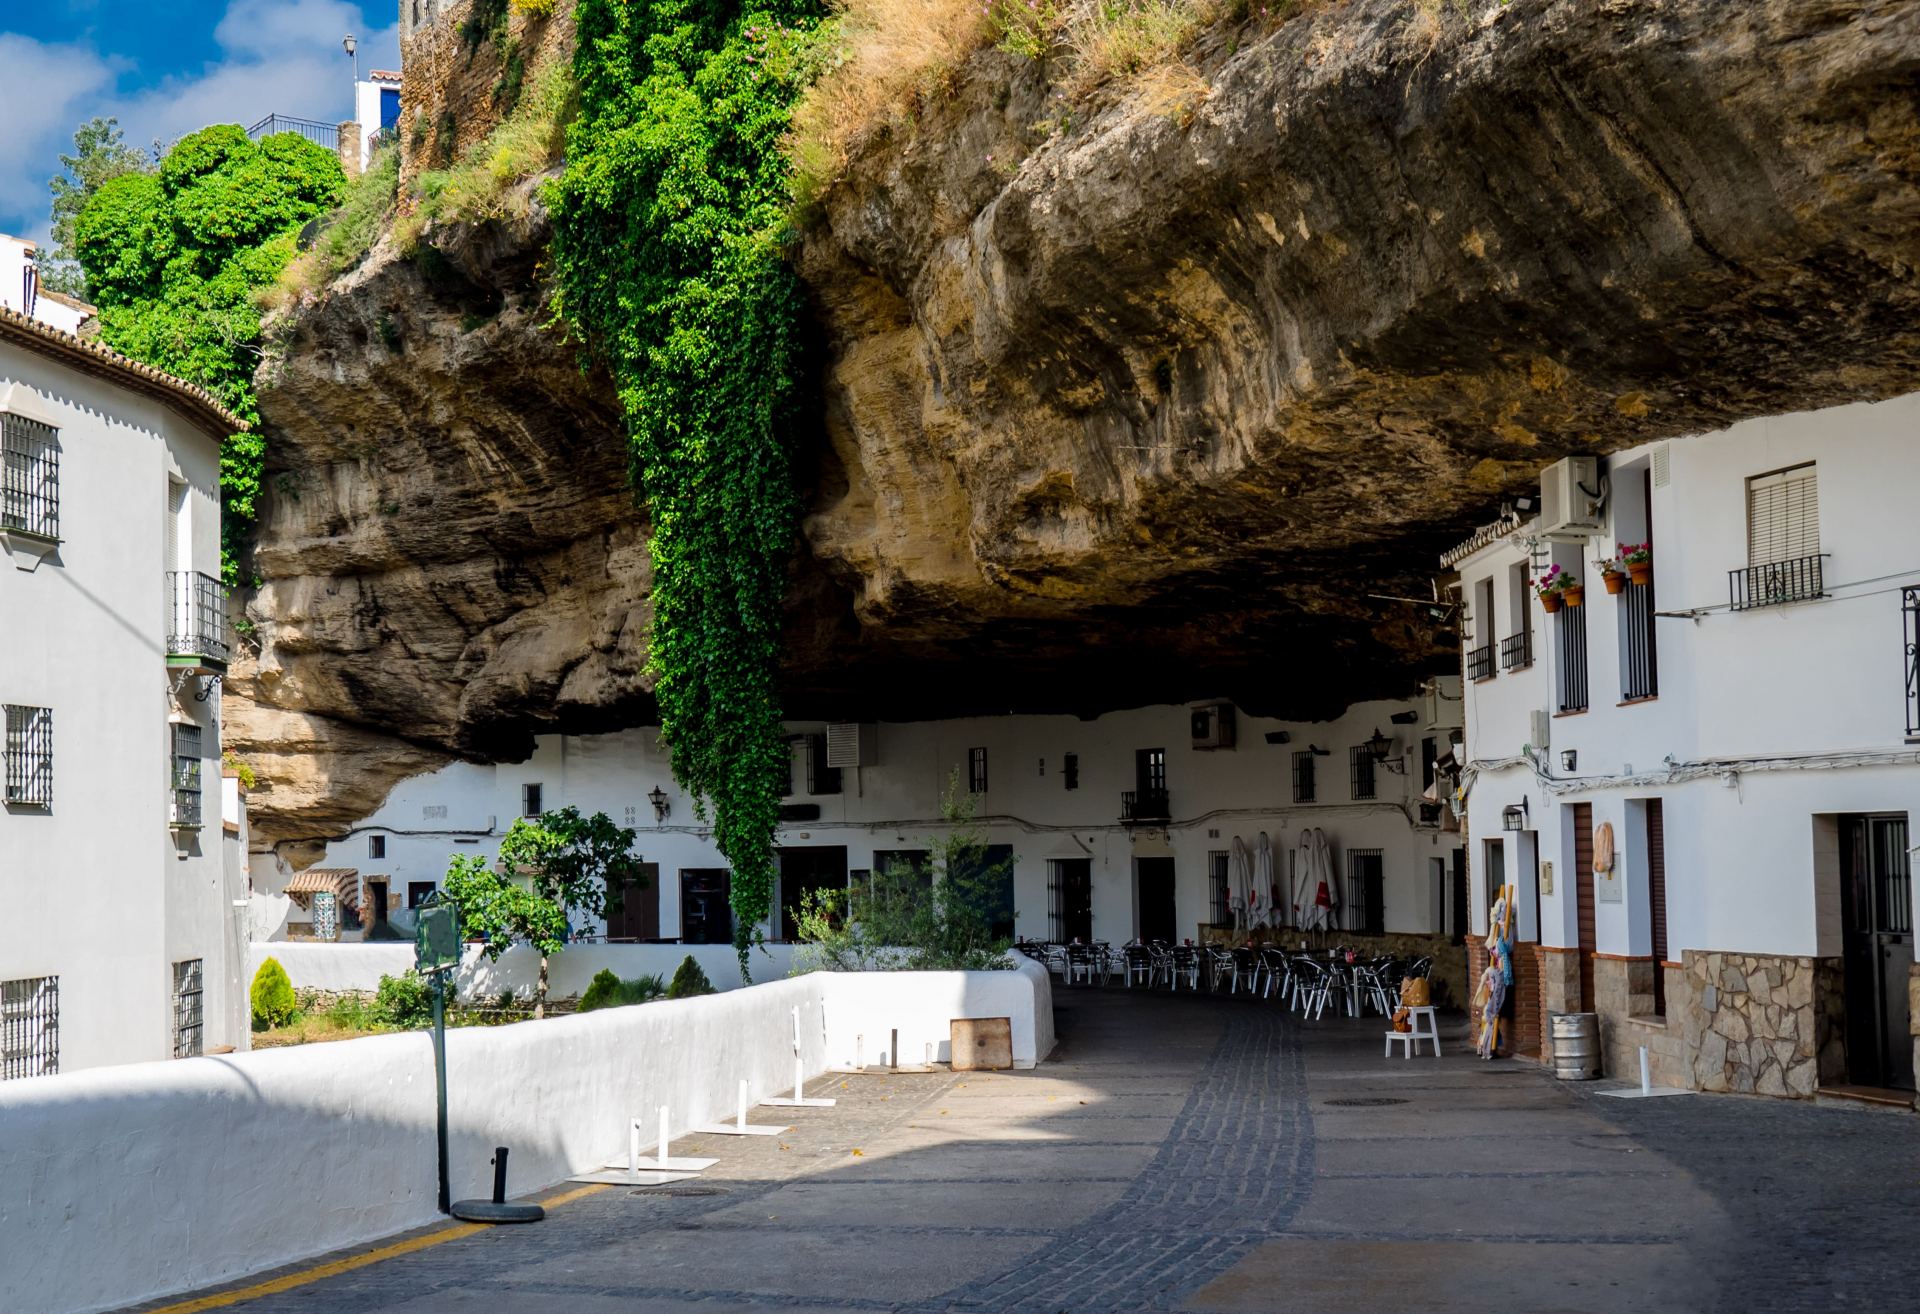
1668, 949, 1847, 1099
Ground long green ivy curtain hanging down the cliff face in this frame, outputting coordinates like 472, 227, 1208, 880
547, 0, 822, 970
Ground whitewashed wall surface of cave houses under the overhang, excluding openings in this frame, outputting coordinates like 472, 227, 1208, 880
253, 701, 1455, 943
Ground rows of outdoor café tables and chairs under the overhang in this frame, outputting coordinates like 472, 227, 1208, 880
1014, 939, 1432, 1020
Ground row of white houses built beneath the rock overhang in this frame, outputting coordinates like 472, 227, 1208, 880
253, 699, 1465, 983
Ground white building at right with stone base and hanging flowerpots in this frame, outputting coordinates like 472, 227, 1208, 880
1444, 396, 1920, 1097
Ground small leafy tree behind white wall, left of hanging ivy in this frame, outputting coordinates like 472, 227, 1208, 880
445, 807, 645, 1018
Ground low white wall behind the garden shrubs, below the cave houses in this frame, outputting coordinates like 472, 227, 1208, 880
248, 939, 795, 999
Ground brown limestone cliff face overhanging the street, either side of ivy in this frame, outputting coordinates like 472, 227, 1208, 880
228, 0, 1920, 838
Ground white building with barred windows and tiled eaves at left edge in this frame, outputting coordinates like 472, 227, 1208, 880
0, 309, 248, 1078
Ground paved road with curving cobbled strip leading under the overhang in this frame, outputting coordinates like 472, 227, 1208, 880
131, 989, 1920, 1314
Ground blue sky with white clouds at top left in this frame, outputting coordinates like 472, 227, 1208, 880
0, 0, 399, 240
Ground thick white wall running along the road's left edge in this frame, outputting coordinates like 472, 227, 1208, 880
0, 945, 1054, 1314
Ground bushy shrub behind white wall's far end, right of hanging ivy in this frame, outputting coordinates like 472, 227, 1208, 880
795, 770, 1012, 972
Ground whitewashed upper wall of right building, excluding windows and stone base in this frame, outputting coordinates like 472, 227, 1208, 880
1461, 396, 1920, 961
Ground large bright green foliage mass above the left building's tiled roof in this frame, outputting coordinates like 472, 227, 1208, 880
73, 123, 346, 584
